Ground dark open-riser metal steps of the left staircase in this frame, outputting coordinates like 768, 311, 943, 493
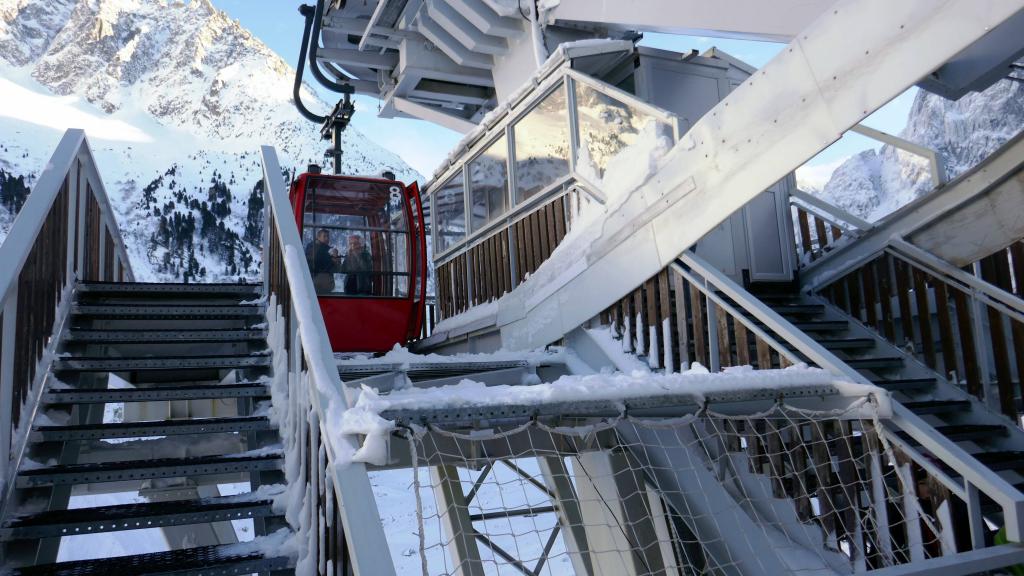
0, 282, 293, 574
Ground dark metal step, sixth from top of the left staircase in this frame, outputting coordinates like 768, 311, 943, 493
30, 416, 271, 442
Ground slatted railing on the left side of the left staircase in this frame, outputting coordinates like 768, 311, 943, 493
0, 129, 133, 502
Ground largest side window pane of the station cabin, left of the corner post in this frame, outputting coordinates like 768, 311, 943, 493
515, 86, 569, 202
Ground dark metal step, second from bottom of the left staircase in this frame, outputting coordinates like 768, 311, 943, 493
0, 496, 274, 541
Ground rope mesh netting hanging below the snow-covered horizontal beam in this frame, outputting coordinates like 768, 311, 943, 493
389, 401, 950, 575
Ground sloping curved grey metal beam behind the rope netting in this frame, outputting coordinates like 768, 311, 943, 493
616, 423, 851, 575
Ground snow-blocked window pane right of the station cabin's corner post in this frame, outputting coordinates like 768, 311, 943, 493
575, 82, 669, 177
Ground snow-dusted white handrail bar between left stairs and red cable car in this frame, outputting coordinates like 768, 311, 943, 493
260, 146, 395, 576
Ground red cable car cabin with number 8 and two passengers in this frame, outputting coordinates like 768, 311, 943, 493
289, 168, 427, 352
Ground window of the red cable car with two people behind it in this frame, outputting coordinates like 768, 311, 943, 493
302, 178, 411, 298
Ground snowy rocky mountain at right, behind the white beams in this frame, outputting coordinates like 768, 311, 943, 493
809, 80, 1024, 221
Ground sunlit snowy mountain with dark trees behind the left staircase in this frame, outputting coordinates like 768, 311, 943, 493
0, 0, 421, 281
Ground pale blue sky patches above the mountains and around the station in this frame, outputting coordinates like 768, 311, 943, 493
212, 0, 916, 178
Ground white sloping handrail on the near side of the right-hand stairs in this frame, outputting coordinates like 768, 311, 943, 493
673, 252, 1024, 546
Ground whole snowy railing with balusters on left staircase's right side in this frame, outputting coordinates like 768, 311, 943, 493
261, 146, 395, 576
